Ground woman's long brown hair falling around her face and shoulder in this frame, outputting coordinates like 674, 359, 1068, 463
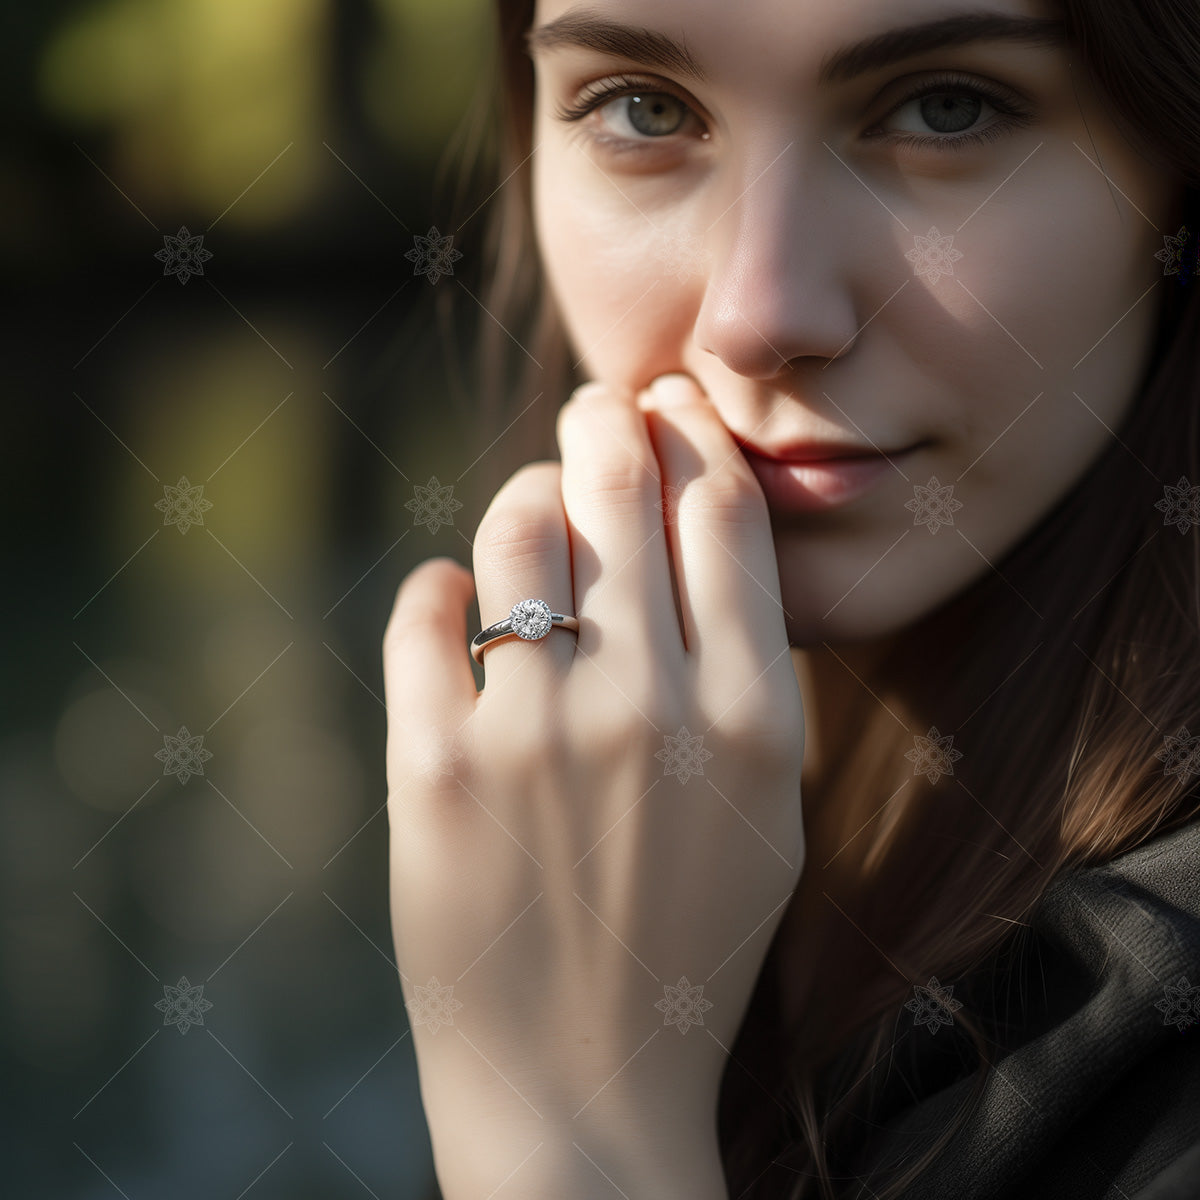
436, 0, 1200, 1200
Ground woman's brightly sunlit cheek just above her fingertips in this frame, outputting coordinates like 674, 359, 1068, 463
534, 154, 703, 388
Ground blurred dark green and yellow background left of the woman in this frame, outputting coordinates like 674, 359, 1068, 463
0, 0, 518, 1200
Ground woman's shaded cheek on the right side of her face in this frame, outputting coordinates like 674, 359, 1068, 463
889, 158, 1160, 494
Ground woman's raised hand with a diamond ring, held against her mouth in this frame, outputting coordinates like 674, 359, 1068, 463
383, 376, 804, 1192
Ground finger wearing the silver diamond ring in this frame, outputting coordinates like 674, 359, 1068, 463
474, 461, 575, 702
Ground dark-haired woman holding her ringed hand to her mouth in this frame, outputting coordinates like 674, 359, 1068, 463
384, 0, 1200, 1200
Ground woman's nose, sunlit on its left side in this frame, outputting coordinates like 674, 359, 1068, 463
694, 143, 859, 379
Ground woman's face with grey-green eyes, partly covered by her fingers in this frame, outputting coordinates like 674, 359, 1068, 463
532, 0, 1178, 647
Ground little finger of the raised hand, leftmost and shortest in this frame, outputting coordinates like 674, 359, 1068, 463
383, 557, 478, 787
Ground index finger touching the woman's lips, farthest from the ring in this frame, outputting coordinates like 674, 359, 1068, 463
638, 374, 787, 686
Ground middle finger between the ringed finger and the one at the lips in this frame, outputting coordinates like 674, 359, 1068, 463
558, 383, 684, 670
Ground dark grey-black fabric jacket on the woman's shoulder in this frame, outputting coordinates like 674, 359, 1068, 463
839, 822, 1200, 1200
